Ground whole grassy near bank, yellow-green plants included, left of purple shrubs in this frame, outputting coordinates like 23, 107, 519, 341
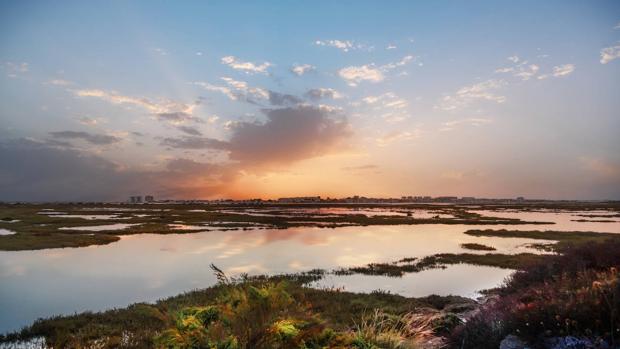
0, 271, 474, 348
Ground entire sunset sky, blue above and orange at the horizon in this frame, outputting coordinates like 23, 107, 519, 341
0, 0, 620, 201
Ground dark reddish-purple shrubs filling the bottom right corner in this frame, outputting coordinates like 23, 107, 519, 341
450, 240, 620, 349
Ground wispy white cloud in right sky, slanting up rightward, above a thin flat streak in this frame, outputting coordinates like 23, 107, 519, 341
438, 79, 506, 111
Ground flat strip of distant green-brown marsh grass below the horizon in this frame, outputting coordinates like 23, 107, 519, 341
0, 204, 556, 251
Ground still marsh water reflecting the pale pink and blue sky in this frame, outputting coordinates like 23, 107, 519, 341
0, 211, 620, 333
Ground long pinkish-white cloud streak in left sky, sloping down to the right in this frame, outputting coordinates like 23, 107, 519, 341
73, 89, 200, 124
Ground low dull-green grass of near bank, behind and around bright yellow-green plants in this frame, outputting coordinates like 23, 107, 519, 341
0, 273, 475, 348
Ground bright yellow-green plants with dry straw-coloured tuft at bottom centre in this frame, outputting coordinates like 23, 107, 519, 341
154, 266, 433, 349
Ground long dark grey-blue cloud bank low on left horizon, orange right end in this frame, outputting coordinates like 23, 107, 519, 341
0, 139, 238, 202
